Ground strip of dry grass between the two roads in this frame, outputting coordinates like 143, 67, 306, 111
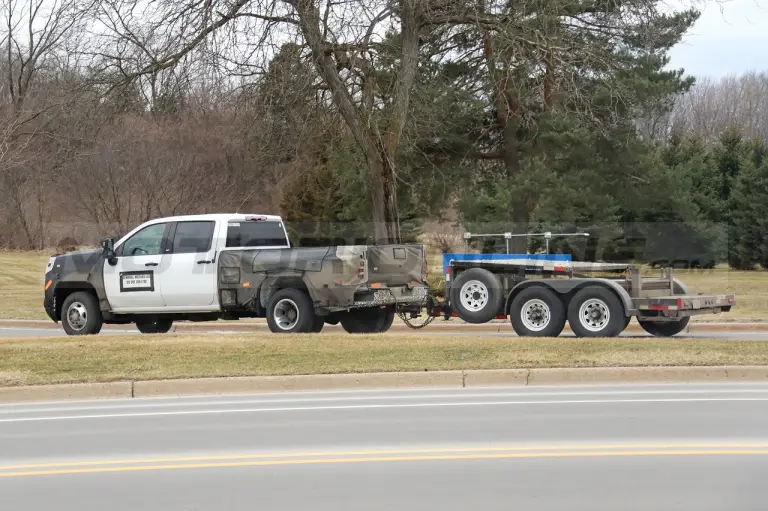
0, 334, 768, 386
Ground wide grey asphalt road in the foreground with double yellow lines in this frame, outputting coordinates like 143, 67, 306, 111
0, 383, 768, 511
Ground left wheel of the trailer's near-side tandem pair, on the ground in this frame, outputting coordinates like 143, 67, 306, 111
509, 287, 566, 337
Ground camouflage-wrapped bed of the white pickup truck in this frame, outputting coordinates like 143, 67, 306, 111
218, 245, 428, 312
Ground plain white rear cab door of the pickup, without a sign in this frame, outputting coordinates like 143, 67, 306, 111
159, 220, 217, 312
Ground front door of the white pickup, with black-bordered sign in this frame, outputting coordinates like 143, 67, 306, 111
104, 223, 170, 312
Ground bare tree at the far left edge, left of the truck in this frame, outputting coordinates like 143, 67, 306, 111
0, 0, 95, 248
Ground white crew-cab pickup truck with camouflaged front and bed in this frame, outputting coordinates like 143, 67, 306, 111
44, 214, 428, 335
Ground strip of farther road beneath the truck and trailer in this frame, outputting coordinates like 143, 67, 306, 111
0, 325, 768, 341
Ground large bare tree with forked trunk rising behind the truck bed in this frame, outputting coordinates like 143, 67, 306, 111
89, 0, 436, 241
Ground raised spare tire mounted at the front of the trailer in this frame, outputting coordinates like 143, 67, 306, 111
450, 268, 504, 323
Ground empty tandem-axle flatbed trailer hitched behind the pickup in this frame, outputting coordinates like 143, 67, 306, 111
414, 259, 736, 337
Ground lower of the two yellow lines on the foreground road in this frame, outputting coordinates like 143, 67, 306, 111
0, 449, 768, 478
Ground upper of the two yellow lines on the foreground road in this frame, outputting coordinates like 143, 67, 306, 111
0, 442, 768, 473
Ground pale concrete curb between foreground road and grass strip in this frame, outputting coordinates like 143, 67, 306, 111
0, 366, 768, 403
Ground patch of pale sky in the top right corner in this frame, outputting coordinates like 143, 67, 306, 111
670, 0, 768, 78
